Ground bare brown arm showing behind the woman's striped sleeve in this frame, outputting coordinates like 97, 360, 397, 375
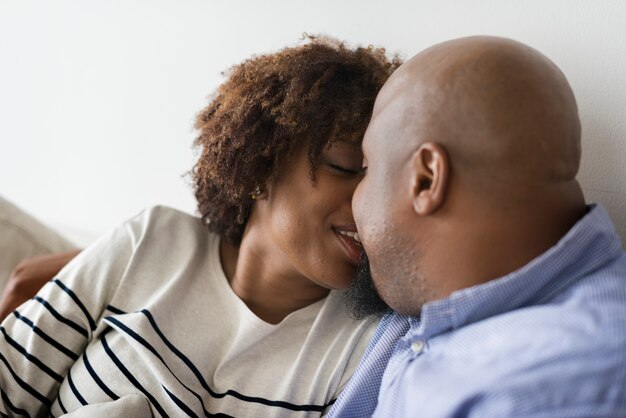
0, 250, 81, 321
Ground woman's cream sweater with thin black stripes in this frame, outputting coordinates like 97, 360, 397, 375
0, 207, 376, 417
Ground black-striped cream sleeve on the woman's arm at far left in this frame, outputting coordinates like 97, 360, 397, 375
0, 214, 141, 416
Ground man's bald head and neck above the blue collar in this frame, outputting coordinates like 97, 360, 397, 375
353, 37, 586, 315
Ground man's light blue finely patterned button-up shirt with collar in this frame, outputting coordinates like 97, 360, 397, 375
328, 205, 626, 418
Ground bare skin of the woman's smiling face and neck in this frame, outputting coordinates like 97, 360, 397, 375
221, 142, 362, 323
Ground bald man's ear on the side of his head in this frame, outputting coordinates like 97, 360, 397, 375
411, 142, 450, 216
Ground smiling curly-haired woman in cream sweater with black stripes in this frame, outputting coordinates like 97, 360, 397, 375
0, 38, 399, 417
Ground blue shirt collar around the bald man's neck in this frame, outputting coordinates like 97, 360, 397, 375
409, 204, 622, 338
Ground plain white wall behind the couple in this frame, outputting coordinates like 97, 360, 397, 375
0, 0, 626, 247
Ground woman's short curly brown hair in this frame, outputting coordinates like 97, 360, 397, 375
193, 36, 400, 244
